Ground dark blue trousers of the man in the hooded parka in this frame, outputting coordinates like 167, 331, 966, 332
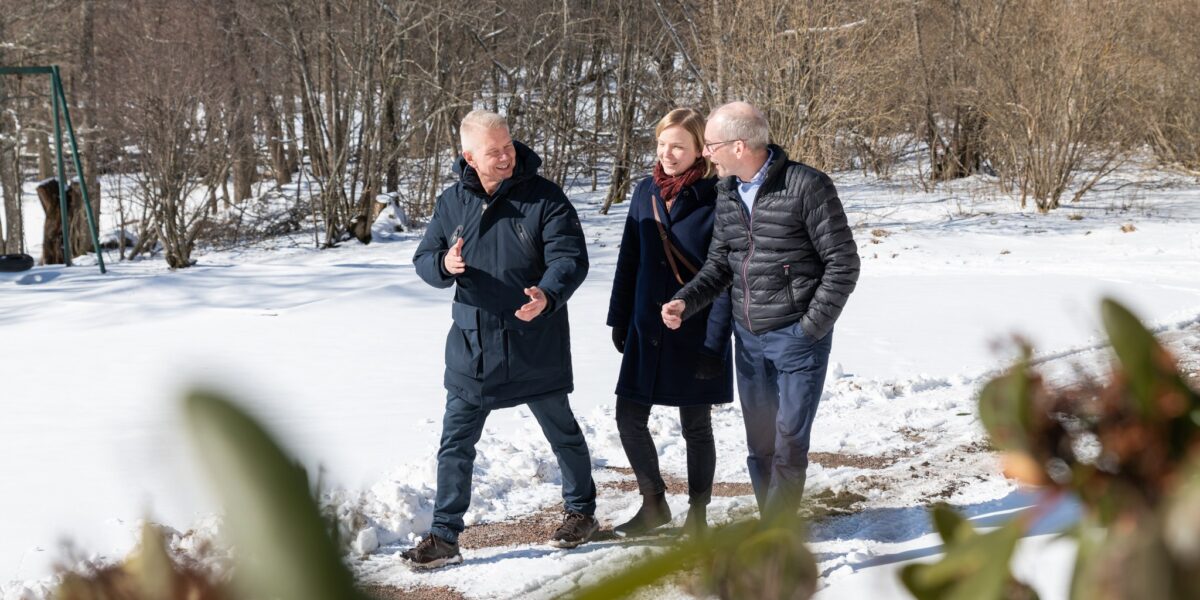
431, 394, 596, 542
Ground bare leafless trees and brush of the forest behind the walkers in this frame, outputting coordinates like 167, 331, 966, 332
0, 0, 1200, 268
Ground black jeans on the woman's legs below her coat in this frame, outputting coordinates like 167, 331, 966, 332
617, 397, 716, 506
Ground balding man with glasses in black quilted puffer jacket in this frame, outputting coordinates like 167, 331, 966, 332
662, 102, 859, 512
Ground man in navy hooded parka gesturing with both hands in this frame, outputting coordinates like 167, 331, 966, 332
403, 110, 596, 569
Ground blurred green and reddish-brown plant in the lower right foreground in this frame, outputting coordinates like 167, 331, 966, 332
901, 300, 1200, 600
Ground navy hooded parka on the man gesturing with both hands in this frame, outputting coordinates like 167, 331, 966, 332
413, 142, 588, 409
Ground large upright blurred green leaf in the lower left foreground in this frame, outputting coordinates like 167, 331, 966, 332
185, 390, 362, 600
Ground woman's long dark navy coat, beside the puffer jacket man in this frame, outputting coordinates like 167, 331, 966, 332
608, 178, 733, 406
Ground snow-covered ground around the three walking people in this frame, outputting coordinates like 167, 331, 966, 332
0, 162, 1200, 600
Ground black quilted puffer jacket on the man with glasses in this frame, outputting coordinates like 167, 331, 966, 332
674, 145, 859, 340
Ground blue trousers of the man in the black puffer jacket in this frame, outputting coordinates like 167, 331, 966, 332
734, 322, 833, 515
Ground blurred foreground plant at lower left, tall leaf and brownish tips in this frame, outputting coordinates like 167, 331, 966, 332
55, 390, 366, 600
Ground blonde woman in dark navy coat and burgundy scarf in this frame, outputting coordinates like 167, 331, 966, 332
608, 108, 733, 536
